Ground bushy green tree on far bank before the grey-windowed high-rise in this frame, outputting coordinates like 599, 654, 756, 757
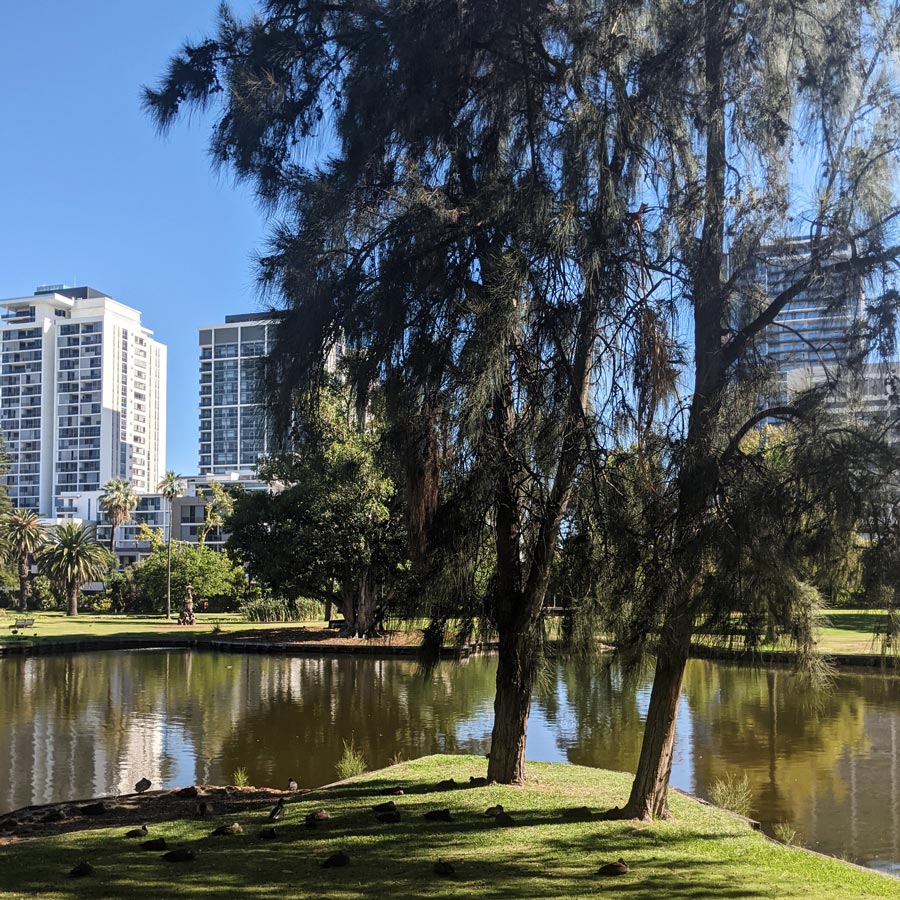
226, 388, 407, 637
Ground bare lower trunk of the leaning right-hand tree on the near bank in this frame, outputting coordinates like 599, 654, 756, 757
604, 616, 691, 821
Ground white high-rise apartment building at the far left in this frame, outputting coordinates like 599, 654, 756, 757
0, 285, 166, 522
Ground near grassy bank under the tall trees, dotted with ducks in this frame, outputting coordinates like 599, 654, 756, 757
0, 756, 900, 900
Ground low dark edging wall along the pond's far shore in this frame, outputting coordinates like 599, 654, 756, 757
0, 635, 900, 671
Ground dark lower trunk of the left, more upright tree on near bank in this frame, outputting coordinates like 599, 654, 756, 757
488, 629, 537, 784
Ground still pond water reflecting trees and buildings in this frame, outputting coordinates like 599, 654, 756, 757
0, 651, 900, 874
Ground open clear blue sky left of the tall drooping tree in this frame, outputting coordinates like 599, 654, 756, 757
0, 0, 264, 475
